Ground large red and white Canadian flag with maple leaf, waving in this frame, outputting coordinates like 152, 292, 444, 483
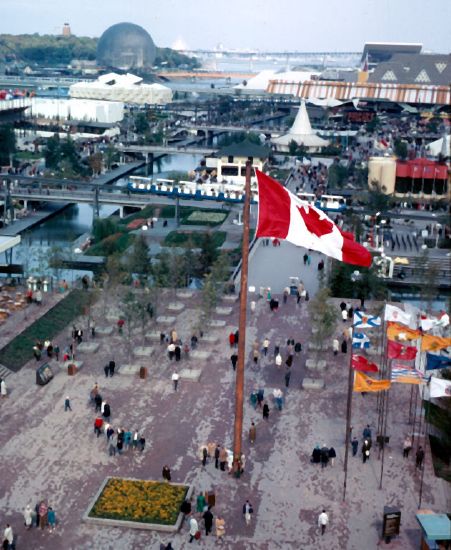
255, 170, 372, 267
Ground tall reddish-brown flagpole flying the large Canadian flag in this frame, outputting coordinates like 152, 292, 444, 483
233, 160, 252, 477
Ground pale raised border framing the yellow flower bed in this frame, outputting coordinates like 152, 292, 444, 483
82, 477, 194, 533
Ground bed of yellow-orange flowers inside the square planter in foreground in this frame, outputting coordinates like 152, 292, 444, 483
89, 478, 188, 525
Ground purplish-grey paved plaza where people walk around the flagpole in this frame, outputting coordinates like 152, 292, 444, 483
0, 272, 446, 550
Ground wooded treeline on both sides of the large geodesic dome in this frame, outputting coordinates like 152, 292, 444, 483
0, 34, 200, 69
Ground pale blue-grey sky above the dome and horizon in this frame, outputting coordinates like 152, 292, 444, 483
0, 0, 451, 53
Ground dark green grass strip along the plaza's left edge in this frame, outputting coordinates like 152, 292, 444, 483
0, 289, 90, 372
